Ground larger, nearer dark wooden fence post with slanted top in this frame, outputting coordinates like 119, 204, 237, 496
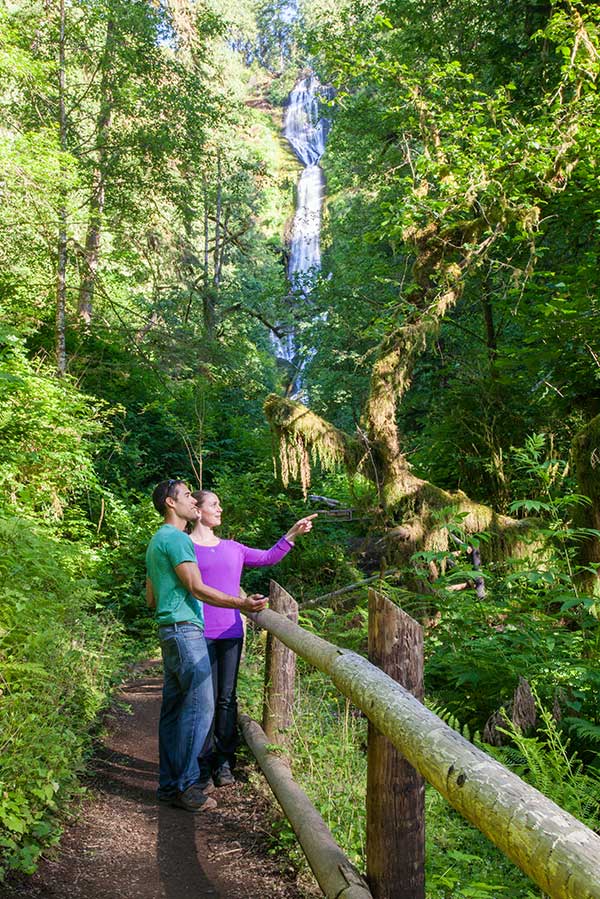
367, 590, 425, 899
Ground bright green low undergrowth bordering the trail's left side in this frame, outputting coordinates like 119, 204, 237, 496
0, 517, 122, 877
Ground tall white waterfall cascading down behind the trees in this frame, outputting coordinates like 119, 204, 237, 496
276, 75, 330, 394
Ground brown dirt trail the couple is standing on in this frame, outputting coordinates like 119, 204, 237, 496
0, 669, 315, 899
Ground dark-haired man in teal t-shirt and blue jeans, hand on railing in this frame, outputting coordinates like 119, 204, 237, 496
146, 478, 267, 812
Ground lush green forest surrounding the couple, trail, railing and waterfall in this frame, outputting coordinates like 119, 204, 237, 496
0, 0, 600, 899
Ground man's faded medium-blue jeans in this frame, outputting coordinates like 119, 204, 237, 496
158, 624, 214, 796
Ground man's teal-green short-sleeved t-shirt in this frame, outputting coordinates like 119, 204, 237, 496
146, 524, 204, 628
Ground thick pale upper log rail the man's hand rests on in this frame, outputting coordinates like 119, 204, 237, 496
245, 585, 600, 899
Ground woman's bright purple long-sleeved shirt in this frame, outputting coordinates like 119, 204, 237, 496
194, 537, 293, 640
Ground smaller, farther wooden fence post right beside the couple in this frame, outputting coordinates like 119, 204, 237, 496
263, 581, 298, 745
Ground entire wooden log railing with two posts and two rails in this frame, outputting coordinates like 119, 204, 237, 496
241, 582, 600, 899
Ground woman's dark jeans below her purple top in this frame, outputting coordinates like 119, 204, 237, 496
200, 637, 244, 780
